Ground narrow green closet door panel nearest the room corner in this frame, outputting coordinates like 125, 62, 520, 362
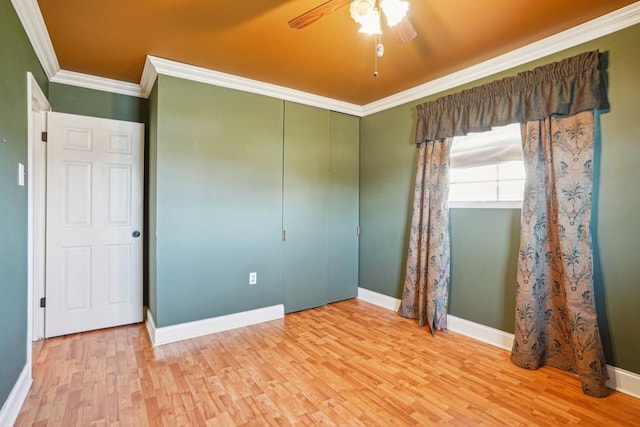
327, 112, 360, 302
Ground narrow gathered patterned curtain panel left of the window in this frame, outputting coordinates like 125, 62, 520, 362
398, 138, 452, 334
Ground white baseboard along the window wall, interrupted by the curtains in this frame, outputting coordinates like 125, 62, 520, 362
358, 288, 640, 399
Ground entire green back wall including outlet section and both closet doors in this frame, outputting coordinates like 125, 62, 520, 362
147, 75, 359, 327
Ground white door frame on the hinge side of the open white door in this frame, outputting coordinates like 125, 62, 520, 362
27, 72, 51, 354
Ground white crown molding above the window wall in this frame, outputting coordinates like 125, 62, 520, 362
362, 2, 640, 116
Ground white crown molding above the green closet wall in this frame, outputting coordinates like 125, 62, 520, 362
140, 56, 362, 116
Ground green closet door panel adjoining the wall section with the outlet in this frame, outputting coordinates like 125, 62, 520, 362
282, 102, 330, 313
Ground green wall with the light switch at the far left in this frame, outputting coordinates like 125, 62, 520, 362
0, 1, 47, 408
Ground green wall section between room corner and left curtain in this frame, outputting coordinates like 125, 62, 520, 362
359, 106, 416, 297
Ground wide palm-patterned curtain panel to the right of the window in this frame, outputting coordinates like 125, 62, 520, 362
511, 110, 608, 397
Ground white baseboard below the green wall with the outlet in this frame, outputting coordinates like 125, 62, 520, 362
146, 304, 284, 347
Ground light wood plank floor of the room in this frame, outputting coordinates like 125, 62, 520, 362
17, 300, 640, 426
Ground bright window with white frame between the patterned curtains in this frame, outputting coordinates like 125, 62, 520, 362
449, 123, 524, 208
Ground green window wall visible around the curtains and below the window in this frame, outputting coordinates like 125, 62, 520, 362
360, 25, 640, 373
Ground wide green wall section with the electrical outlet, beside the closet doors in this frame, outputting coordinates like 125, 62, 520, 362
150, 75, 283, 327
